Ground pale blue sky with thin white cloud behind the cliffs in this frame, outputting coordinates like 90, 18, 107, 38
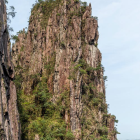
9, 0, 140, 140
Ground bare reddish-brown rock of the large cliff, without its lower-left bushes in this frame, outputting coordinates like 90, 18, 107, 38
12, 0, 116, 140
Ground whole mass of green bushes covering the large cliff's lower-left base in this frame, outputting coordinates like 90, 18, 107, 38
16, 78, 72, 140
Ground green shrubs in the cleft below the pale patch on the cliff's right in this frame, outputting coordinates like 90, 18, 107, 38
69, 59, 107, 112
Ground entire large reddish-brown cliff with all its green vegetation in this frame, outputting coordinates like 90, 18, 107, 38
12, 0, 117, 140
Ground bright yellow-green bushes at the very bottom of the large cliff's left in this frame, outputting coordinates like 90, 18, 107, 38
28, 116, 66, 140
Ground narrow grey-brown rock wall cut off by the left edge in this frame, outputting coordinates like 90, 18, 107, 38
0, 0, 20, 140
